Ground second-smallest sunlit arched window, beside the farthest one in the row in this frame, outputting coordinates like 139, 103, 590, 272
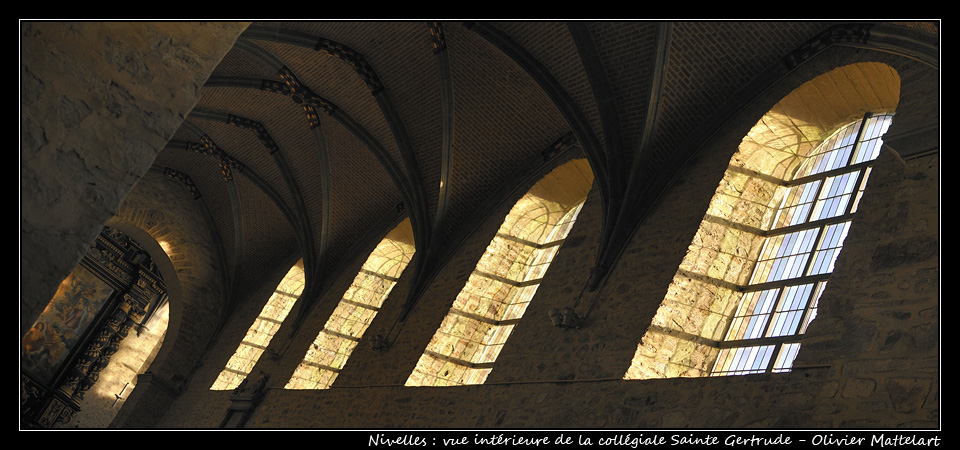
285, 219, 416, 389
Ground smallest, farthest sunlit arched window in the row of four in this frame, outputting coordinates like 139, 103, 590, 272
210, 259, 304, 390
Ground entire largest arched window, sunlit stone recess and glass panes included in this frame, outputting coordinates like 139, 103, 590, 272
624, 63, 899, 379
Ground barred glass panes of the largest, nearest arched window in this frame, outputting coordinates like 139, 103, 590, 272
710, 114, 892, 376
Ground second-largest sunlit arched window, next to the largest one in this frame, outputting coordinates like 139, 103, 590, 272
406, 160, 593, 386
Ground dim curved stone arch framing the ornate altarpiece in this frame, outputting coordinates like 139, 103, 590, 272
101, 171, 227, 428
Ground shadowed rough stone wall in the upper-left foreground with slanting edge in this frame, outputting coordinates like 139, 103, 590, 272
20, 22, 246, 329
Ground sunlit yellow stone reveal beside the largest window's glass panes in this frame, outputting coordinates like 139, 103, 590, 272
624, 62, 900, 379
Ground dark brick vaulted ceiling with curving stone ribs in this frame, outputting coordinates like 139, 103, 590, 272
154, 21, 933, 326
